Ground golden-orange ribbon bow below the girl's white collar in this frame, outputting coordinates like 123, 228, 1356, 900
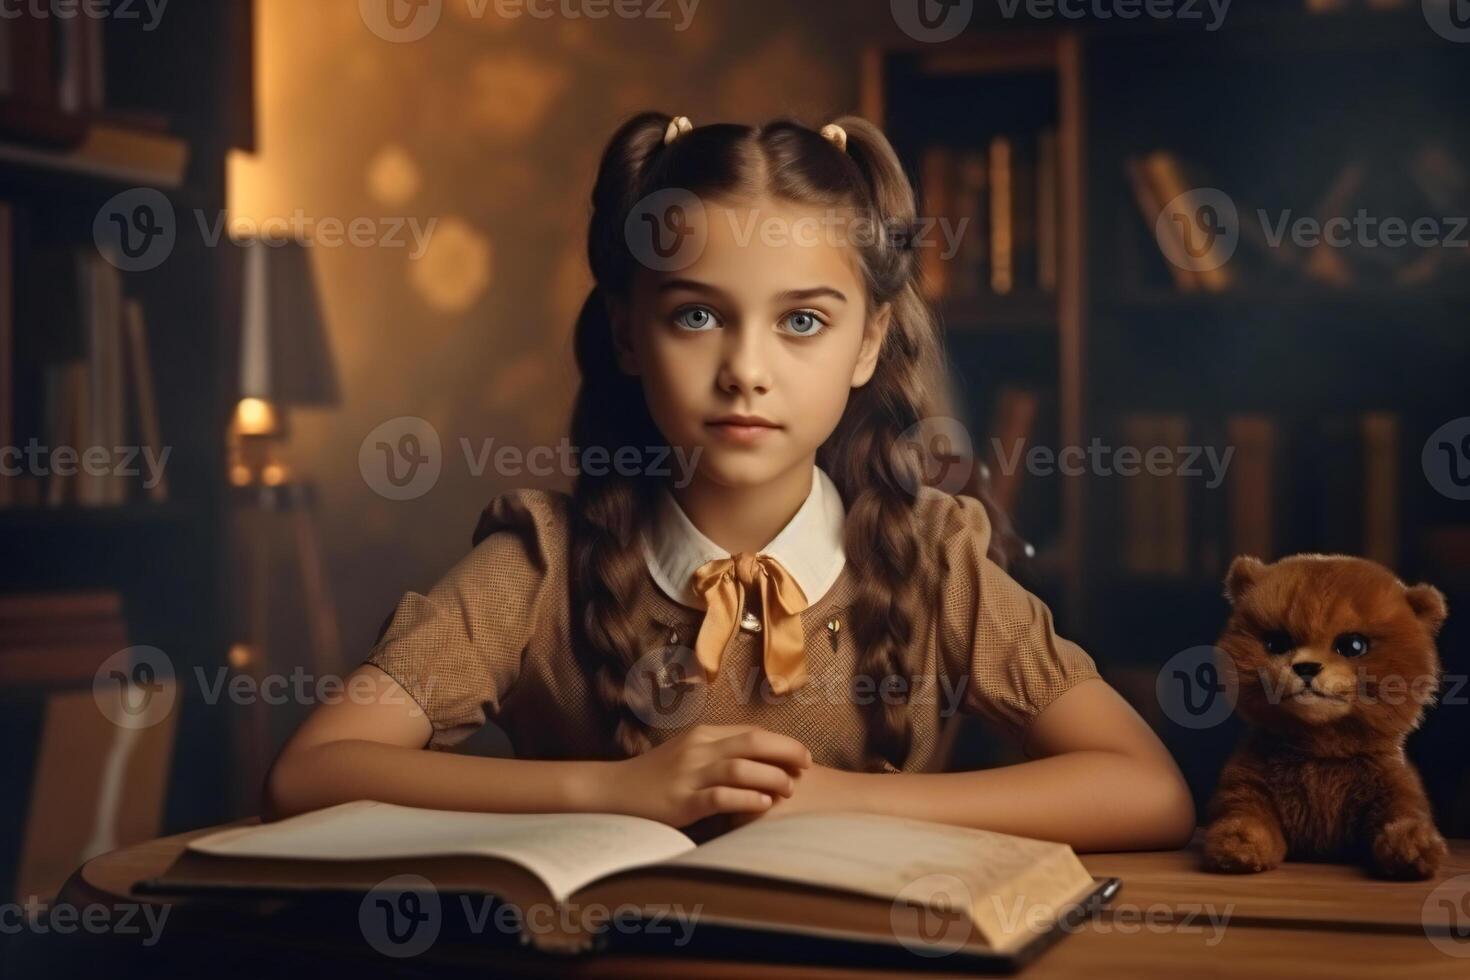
694, 551, 807, 693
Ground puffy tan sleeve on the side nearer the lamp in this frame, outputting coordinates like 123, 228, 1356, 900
365, 491, 560, 749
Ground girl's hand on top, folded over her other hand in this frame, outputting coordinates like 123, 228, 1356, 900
607, 724, 811, 827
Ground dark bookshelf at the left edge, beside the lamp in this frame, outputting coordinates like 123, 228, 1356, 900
0, 0, 253, 889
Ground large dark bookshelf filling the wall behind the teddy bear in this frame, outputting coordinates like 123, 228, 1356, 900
863, 3, 1470, 833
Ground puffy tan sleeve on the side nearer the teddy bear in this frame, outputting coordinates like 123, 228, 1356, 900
935, 491, 1098, 745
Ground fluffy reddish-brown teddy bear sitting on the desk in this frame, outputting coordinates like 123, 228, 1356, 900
1204, 555, 1446, 879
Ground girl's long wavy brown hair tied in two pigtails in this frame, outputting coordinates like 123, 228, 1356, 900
569, 113, 1013, 770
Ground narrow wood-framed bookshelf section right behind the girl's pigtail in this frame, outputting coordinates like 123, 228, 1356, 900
863, 32, 1088, 620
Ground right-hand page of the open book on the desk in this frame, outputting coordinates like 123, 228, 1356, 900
666, 813, 1092, 915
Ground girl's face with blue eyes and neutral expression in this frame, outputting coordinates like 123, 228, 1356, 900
613, 198, 889, 488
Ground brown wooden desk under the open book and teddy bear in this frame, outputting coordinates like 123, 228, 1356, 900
21, 829, 1470, 980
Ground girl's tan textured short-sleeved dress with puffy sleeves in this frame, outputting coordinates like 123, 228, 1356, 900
366, 488, 1098, 773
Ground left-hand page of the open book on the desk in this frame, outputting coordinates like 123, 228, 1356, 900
188, 799, 694, 901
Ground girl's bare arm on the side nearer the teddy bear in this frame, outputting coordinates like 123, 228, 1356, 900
738, 677, 1195, 851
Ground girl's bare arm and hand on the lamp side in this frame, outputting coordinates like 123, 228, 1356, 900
262, 664, 811, 827
